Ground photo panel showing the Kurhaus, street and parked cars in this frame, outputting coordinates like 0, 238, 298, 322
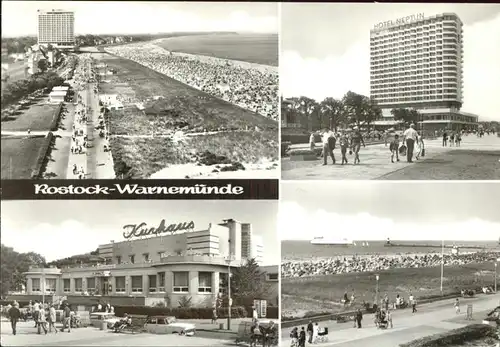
1, 200, 280, 346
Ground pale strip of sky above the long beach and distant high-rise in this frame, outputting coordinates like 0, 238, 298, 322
2, 1, 279, 37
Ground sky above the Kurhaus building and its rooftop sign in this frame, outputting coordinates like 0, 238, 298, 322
1, 200, 280, 265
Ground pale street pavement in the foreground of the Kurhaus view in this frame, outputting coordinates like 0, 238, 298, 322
1, 321, 234, 347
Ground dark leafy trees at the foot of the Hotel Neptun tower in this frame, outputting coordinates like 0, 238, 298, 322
285, 91, 421, 131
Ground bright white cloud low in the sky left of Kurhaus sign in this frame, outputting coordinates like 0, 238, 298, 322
2, 218, 110, 261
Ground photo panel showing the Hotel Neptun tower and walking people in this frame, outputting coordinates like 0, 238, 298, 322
280, 3, 500, 180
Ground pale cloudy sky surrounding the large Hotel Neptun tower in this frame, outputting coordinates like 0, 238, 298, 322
280, 3, 500, 121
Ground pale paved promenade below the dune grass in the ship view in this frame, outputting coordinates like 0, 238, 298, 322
281, 293, 500, 347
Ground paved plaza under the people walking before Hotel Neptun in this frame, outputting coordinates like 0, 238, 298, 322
281, 135, 500, 180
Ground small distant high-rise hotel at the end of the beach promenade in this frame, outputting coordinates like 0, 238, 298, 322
38, 10, 75, 49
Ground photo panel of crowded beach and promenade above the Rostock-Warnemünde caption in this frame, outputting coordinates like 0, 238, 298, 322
1, 1, 280, 179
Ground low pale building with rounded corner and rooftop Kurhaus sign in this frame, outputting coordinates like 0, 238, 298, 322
20, 219, 263, 305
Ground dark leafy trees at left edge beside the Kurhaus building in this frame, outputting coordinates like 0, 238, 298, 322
0, 244, 46, 297
